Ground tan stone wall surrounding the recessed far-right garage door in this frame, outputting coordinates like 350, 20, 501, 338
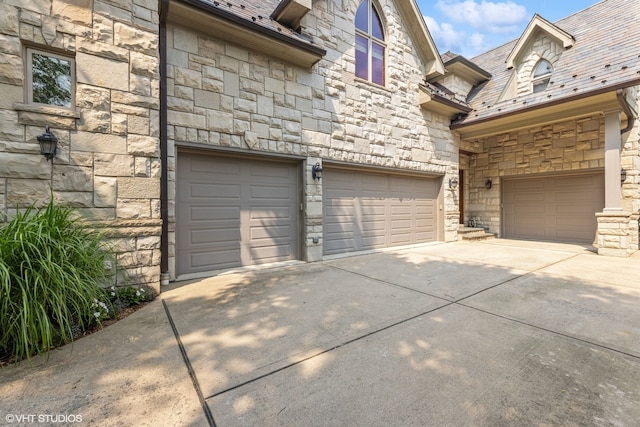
466, 115, 604, 233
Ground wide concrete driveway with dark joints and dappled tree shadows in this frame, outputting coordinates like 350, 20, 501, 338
0, 239, 640, 426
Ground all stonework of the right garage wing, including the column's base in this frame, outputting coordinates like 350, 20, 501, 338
461, 110, 640, 251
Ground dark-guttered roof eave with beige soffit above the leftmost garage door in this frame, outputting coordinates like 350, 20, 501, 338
167, 0, 326, 67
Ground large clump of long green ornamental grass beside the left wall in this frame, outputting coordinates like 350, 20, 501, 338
0, 198, 115, 360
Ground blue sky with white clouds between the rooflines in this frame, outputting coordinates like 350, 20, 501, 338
416, 0, 598, 59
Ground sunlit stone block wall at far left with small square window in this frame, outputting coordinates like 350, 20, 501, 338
0, 0, 160, 289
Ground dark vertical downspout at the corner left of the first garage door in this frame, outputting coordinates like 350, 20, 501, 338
158, 0, 169, 286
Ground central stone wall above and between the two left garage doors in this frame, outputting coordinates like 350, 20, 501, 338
167, 0, 458, 278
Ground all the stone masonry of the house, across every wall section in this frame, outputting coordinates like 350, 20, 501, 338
0, 0, 640, 289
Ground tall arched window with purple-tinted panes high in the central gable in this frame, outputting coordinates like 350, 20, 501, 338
355, 0, 386, 85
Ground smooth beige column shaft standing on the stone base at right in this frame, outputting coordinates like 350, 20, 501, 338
604, 111, 622, 212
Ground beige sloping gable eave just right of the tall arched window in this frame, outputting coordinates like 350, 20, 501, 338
394, 0, 445, 80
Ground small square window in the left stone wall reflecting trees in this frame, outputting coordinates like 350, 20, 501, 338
25, 47, 75, 109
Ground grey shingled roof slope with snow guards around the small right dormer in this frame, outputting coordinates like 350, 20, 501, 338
451, 0, 640, 137
